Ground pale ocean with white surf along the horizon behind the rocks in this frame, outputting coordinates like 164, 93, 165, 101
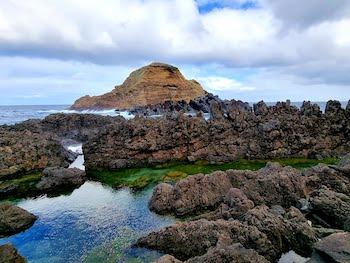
0, 101, 347, 125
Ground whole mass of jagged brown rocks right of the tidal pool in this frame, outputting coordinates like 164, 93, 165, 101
137, 158, 350, 262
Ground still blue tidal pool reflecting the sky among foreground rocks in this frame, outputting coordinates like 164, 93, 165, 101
0, 182, 175, 263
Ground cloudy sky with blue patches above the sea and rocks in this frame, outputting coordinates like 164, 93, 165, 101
0, 0, 350, 105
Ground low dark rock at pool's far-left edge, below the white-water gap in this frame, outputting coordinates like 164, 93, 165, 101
36, 167, 86, 193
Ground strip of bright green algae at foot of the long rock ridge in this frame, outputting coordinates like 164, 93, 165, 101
89, 158, 339, 190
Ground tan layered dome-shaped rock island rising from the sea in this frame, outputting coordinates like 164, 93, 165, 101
71, 63, 205, 110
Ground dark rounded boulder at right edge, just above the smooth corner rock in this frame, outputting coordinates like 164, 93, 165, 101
310, 186, 350, 231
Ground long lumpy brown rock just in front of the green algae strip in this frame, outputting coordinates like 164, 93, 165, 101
150, 163, 305, 216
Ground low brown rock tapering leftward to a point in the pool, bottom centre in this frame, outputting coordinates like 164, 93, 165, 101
137, 219, 278, 260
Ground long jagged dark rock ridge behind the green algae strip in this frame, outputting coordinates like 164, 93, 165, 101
84, 101, 350, 170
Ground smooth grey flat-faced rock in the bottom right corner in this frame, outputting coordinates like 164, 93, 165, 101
309, 232, 350, 263
